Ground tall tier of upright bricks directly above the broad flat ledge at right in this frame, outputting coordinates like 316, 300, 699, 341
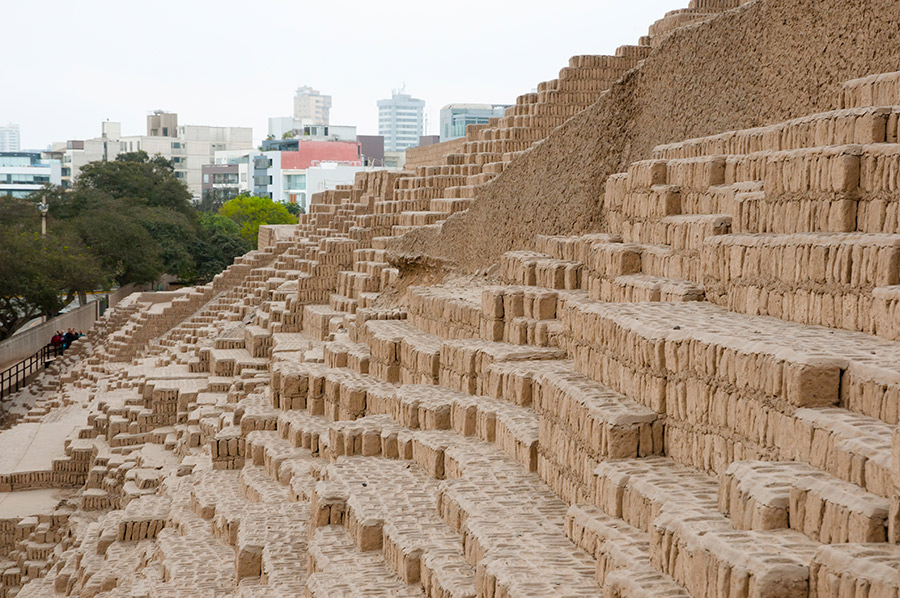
703, 233, 900, 340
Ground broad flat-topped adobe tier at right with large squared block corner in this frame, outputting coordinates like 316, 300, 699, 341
559, 298, 900, 482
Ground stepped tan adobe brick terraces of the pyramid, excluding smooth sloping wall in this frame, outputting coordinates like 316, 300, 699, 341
0, 1, 900, 598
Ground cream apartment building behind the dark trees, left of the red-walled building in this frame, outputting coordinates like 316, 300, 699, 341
52, 111, 253, 201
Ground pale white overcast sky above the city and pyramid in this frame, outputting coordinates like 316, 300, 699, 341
0, 0, 688, 149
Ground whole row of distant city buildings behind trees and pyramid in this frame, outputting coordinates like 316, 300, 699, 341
0, 85, 508, 209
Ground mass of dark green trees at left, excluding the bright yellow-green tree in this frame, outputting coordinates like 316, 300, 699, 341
0, 151, 255, 340
